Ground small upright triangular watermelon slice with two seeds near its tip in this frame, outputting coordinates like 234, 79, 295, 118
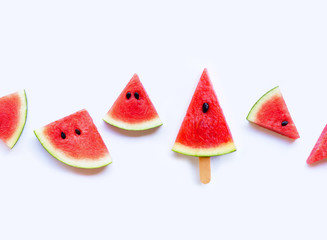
103, 74, 162, 130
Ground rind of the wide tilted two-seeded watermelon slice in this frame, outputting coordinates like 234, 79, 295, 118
34, 127, 112, 169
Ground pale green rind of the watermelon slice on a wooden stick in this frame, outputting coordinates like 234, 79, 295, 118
172, 141, 236, 157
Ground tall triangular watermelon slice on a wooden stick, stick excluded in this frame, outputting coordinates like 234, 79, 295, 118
172, 69, 236, 157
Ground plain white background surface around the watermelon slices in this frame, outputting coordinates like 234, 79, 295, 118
0, 0, 327, 240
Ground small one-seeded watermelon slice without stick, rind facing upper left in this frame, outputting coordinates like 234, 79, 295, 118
246, 86, 300, 139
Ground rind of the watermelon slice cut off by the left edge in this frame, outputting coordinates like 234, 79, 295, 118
5, 90, 27, 149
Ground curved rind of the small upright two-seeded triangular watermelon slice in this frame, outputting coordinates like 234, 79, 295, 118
102, 114, 163, 131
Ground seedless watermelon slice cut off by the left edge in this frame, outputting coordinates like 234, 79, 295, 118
0, 90, 27, 148
